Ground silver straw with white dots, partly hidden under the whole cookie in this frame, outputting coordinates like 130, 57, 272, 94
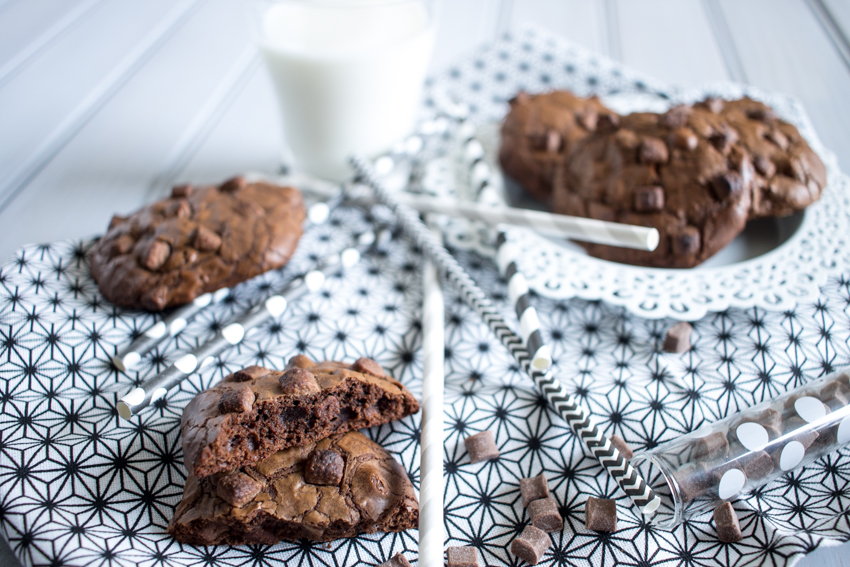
112, 197, 341, 372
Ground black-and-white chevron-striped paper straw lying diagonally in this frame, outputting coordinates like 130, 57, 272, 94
351, 157, 661, 515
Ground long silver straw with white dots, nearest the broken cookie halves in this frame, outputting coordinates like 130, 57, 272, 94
117, 232, 375, 419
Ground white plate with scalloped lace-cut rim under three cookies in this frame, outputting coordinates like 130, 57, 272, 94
425, 78, 850, 320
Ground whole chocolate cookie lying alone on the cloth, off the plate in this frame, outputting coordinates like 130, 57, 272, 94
91, 177, 306, 311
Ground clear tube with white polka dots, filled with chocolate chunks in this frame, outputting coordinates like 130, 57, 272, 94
631, 372, 850, 529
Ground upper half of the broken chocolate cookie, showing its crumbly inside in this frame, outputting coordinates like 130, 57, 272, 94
180, 355, 419, 478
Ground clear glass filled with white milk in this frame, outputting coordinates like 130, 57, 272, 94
256, 0, 436, 181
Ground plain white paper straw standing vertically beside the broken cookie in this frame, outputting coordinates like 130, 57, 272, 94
419, 248, 446, 567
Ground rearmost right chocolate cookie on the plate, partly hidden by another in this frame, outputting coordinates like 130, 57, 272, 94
696, 98, 826, 218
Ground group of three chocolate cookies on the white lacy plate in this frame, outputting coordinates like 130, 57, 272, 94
499, 91, 826, 268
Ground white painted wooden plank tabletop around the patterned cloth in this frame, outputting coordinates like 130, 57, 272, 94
0, 0, 850, 567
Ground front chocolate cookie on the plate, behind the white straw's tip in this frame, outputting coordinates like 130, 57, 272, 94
552, 106, 753, 268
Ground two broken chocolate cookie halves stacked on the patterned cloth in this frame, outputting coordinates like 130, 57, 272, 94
168, 355, 419, 545
